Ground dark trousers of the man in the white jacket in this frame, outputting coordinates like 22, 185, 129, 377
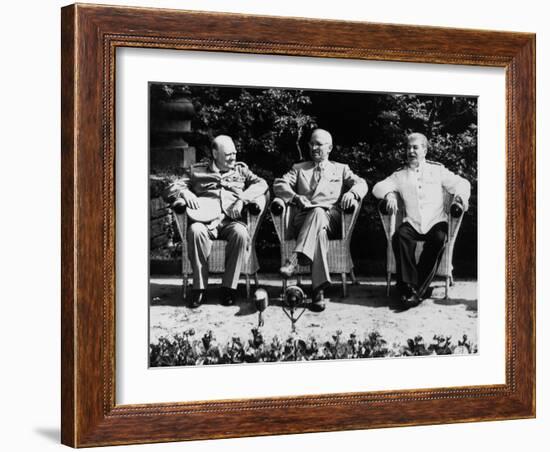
392, 221, 448, 296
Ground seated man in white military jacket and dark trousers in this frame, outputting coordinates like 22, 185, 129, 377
372, 133, 470, 307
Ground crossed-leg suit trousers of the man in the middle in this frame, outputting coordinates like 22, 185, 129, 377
292, 207, 341, 289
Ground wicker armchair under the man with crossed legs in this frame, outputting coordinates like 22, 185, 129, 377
270, 198, 362, 297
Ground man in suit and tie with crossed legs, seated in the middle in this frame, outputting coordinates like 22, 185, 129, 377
273, 129, 368, 312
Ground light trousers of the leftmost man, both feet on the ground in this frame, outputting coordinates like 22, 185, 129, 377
187, 221, 250, 290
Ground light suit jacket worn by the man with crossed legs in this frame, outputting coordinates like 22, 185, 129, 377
273, 160, 368, 207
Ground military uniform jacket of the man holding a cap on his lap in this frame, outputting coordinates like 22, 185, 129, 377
168, 161, 268, 214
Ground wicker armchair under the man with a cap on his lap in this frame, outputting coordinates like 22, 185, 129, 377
174, 192, 269, 300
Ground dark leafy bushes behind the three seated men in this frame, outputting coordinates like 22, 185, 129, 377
151, 84, 478, 276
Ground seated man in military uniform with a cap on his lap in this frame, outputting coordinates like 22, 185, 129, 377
168, 135, 268, 308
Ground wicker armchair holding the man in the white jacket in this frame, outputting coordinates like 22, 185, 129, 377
378, 192, 464, 298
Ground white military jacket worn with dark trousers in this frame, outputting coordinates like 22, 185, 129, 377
372, 160, 470, 234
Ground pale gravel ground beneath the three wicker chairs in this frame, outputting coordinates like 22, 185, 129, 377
150, 275, 478, 350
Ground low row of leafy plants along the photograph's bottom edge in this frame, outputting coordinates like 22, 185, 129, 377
149, 328, 477, 367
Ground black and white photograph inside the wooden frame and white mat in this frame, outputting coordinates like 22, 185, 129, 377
149, 82, 479, 367
